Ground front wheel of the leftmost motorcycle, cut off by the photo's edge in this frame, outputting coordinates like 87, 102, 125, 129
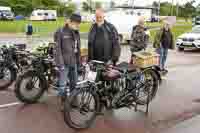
0, 66, 17, 90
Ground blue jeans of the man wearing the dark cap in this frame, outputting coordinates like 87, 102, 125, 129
58, 64, 78, 96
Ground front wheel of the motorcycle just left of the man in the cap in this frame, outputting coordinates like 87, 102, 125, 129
15, 71, 47, 104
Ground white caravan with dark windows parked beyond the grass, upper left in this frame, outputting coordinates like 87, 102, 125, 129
30, 9, 57, 21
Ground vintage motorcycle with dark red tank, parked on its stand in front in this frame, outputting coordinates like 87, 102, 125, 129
64, 61, 159, 129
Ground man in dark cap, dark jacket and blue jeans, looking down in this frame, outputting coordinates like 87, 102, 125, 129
54, 13, 81, 96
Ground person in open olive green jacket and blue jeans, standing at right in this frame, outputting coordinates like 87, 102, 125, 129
153, 21, 175, 73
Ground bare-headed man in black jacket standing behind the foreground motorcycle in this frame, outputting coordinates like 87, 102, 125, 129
88, 9, 121, 64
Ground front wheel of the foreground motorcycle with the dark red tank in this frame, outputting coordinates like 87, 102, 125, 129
64, 89, 100, 129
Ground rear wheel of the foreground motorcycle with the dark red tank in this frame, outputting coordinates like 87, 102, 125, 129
136, 69, 159, 105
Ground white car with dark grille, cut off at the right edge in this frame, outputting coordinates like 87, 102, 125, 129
176, 26, 200, 51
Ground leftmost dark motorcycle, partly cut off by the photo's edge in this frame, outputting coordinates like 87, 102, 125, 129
0, 45, 28, 90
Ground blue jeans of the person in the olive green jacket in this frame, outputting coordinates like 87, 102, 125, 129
156, 47, 168, 70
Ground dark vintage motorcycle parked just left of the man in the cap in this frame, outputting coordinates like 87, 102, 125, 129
15, 44, 58, 104
